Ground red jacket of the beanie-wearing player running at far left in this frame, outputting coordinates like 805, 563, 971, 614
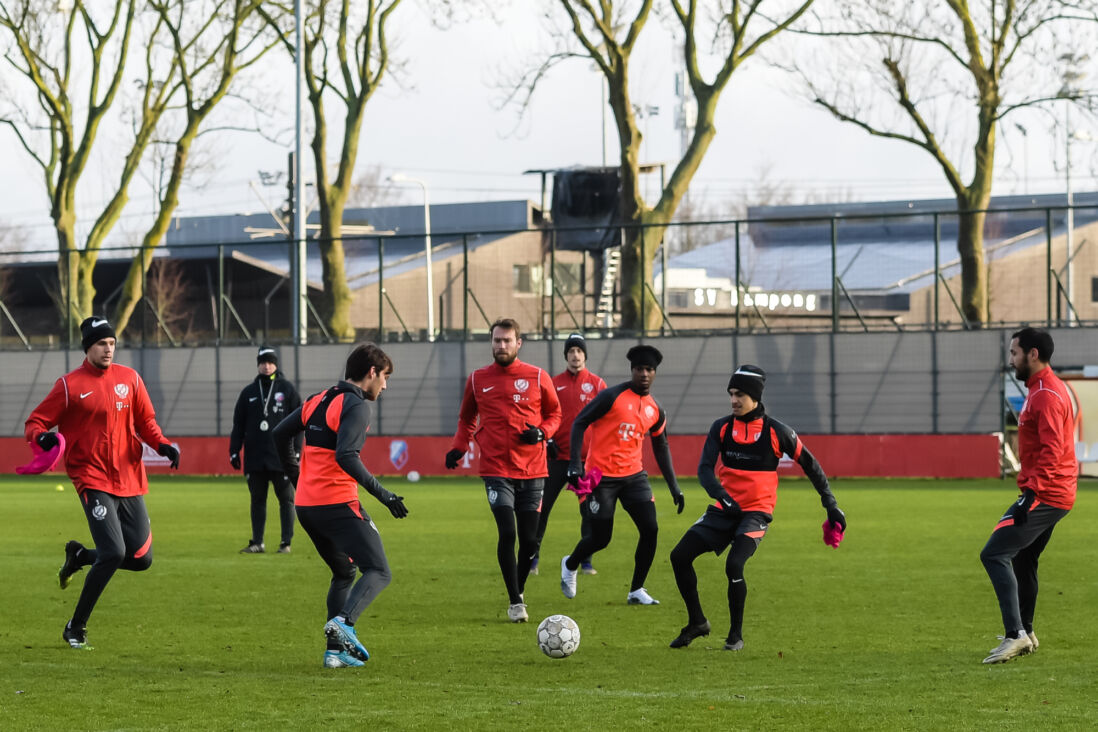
23, 360, 167, 496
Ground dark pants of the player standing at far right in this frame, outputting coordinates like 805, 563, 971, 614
979, 503, 1067, 638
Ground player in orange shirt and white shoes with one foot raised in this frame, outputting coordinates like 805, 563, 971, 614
560, 346, 686, 605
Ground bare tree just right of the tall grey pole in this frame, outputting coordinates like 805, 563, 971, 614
261, 0, 401, 340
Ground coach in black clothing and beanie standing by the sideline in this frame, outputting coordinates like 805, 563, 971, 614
228, 346, 301, 554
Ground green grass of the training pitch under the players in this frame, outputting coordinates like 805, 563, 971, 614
0, 477, 1098, 730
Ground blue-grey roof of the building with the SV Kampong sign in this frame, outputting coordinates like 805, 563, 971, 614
654, 193, 1098, 292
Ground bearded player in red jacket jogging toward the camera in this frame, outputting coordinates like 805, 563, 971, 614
446, 318, 560, 622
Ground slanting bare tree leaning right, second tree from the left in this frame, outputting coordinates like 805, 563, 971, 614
114, 0, 279, 331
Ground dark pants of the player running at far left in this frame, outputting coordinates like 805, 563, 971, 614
72, 491, 153, 628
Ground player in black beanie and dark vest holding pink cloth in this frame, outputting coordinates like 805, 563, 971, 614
671, 364, 847, 651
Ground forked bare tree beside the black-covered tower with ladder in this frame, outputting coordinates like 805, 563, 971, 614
514, 0, 814, 331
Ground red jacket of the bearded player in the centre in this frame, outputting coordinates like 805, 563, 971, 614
451, 359, 560, 480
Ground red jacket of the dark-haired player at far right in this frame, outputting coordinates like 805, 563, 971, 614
1018, 367, 1079, 509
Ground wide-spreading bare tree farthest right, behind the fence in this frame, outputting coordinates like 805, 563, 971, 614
787, 0, 1098, 324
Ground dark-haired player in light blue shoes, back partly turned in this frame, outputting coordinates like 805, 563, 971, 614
273, 344, 408, 668
